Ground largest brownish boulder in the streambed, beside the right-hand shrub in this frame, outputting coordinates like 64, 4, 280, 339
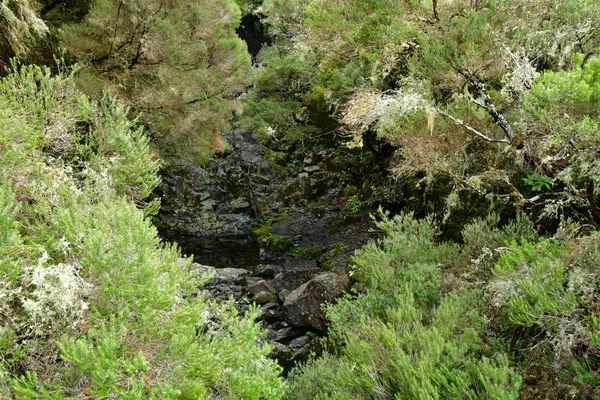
283, 272, 350, 331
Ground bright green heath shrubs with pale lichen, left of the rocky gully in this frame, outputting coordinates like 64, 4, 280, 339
0, 67, 281, 399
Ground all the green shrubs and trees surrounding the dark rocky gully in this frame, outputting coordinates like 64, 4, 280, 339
0, 0, 600, 399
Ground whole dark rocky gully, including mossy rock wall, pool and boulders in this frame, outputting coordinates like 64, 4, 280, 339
155, 131, 380, 370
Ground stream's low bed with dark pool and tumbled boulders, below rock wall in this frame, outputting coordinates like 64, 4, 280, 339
168, 213, 376, 371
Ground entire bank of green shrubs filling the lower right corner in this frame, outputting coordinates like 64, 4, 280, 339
289, 215, 600, 399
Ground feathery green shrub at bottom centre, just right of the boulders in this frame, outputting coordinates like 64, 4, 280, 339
287, 211, 521, 399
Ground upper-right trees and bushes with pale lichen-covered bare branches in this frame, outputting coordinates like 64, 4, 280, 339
243, 0, 600, 229
